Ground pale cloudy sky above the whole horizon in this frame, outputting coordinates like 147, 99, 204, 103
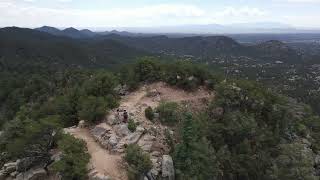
0, 0, 320, 28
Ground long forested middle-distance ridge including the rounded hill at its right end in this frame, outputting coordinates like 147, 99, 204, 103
100, 34, 303, 64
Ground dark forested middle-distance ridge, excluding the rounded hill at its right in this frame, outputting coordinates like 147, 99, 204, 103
103, 35, 247, 58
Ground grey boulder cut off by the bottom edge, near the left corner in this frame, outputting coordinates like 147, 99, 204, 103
16, 168, 48, 180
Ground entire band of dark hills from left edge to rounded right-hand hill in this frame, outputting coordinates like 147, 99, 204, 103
0, 27, 308, 67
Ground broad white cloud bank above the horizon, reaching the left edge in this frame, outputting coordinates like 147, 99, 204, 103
0, 0, 267, 27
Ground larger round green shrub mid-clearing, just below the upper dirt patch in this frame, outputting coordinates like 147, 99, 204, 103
157, 102, 179, 125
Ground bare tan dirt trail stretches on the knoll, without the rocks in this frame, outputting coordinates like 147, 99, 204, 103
69, 83, 212, 180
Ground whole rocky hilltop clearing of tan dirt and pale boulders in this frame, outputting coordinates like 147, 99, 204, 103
66, 83, 212, 180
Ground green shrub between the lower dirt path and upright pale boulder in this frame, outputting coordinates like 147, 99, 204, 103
124, 144, 152, 180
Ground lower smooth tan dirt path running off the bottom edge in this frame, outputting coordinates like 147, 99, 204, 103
69, 128, 127, 180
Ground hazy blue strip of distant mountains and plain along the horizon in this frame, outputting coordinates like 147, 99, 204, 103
35, 23, 320, 43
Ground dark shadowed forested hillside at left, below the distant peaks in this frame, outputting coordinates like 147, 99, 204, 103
0, 28, 147, 67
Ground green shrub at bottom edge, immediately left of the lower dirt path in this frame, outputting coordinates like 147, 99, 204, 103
50, 135, 90, 180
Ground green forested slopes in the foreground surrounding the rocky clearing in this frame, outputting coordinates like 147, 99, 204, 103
0, 55, 320, 180
